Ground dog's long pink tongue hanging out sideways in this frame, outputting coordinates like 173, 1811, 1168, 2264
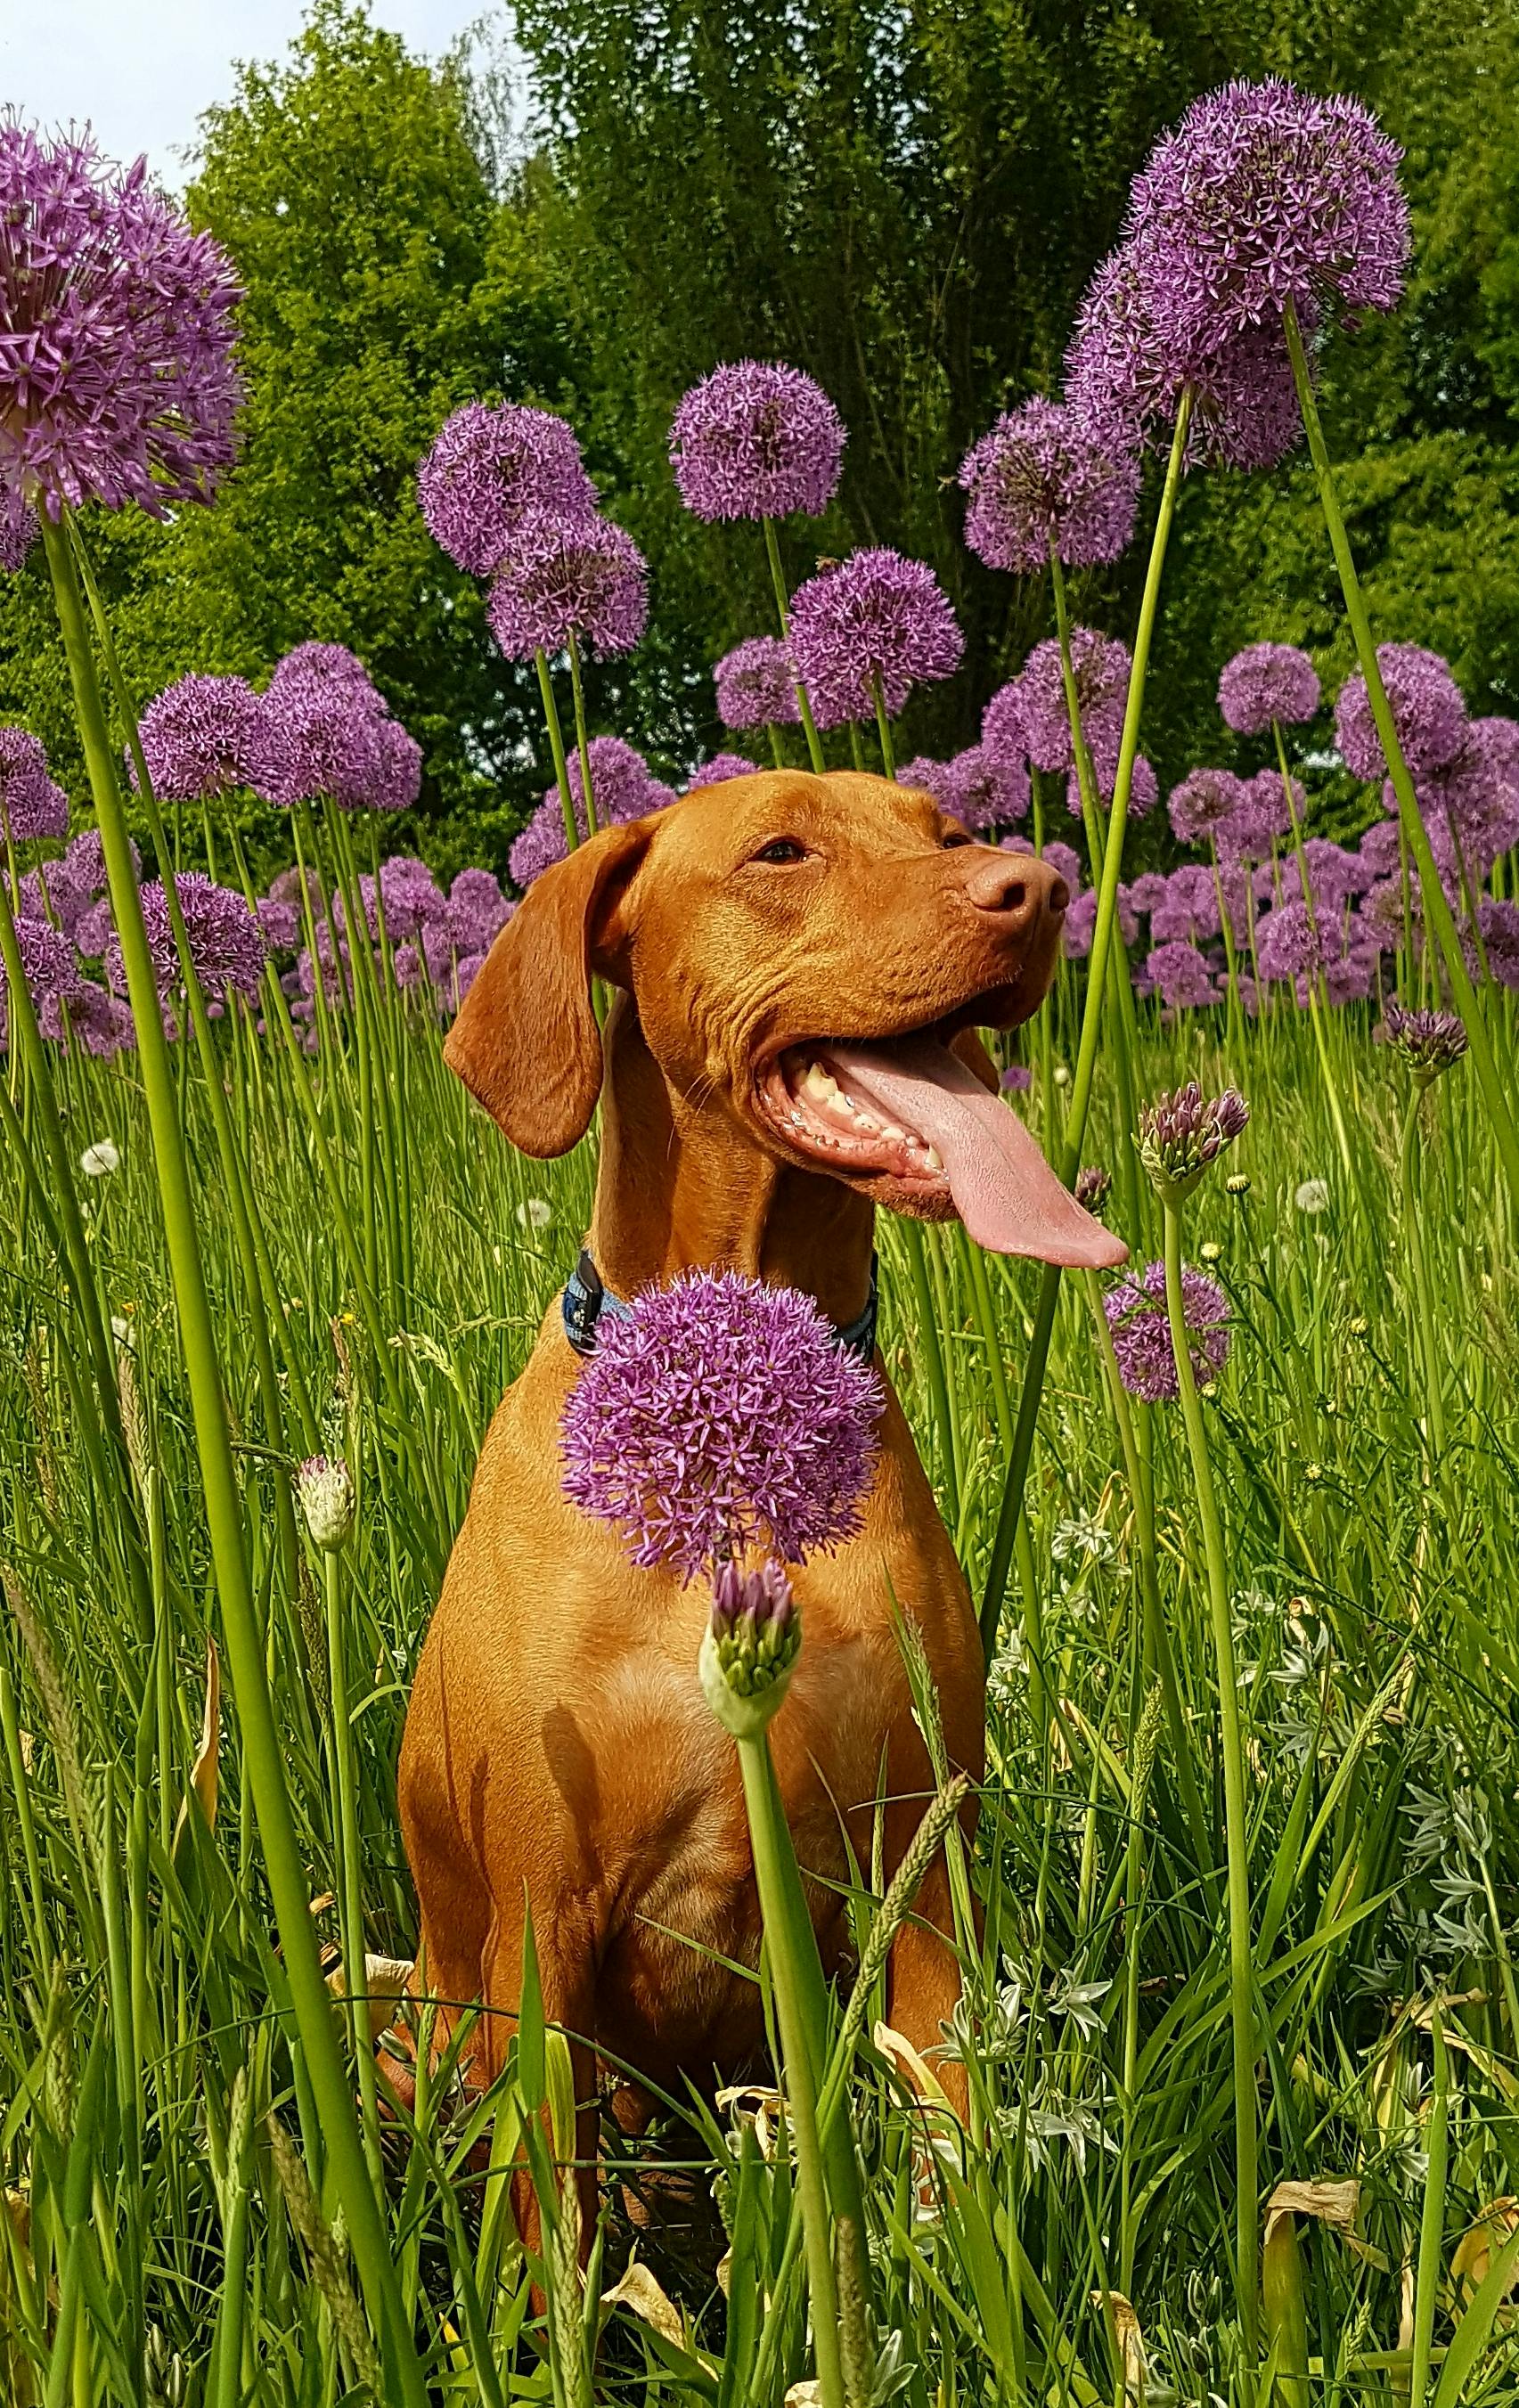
829, 1038, 1129, 1269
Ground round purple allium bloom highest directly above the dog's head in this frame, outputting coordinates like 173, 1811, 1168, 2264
669, 359, 845, 522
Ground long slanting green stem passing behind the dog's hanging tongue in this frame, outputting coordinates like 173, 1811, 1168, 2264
980, 388, 1192, 1657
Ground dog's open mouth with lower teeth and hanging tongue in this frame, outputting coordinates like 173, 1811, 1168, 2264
761, 1025, 1129, 1269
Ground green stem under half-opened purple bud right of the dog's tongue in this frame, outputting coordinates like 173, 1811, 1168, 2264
1163, 1196, 1259, 2387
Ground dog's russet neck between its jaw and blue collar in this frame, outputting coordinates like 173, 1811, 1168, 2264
590, 997, 874, 1326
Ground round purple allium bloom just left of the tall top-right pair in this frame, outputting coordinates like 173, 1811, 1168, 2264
960, 400, 1139, 575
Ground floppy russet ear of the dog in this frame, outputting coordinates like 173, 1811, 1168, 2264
443, 821, 648, 1161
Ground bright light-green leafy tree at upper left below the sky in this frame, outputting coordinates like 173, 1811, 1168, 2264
0, 0, 582, 886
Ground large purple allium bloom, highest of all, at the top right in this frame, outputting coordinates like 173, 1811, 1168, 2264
1129, 77, 1409, 354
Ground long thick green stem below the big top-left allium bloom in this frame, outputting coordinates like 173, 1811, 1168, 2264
38, 510, 426, 2408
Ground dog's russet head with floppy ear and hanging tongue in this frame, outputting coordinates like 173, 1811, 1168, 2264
445, 771, 1124, 1264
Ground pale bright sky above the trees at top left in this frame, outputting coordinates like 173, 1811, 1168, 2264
0, 0, 484, 185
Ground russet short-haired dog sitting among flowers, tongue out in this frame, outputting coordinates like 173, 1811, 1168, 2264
400, 771, 1122, 2215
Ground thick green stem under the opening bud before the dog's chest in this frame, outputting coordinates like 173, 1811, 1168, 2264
734, 1731, 853, 2408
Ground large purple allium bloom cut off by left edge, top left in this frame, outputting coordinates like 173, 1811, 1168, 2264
0, 116, 241, 518
